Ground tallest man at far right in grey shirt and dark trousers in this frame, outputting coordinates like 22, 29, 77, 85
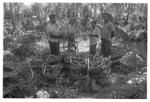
101, 13, 115, 57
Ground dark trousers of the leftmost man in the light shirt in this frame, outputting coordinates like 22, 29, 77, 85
49, 41, 60, 55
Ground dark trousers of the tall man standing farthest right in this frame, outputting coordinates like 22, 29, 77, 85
101, 39, 112, 57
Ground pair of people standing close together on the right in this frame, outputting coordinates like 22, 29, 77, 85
90, 13, 115, 57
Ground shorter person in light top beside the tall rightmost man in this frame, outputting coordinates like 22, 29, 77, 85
89, 21, 100, 56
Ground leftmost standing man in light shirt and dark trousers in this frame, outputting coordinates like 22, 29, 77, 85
46, 14, 62, 56
